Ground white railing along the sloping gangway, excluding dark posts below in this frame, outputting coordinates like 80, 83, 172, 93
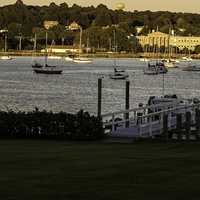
102, 102, 200, 137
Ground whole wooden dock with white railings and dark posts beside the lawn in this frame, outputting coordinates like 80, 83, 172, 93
102, 101, 200, 140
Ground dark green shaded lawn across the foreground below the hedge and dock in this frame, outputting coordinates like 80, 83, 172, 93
0, 140, 200, 200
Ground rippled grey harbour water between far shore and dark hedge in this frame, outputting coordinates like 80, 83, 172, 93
0, 57, 200, 114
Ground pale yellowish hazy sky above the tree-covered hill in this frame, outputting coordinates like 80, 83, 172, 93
0, 0, 200, 13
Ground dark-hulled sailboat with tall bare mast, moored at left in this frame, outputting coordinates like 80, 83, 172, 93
32, 32, 62, 74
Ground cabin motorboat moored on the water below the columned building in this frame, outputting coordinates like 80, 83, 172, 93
144, 62, 168, 75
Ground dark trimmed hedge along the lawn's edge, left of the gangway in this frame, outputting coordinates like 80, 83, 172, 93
0, 108, 104, 140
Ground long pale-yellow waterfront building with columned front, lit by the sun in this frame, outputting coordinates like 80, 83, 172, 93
136, 31, 200, 51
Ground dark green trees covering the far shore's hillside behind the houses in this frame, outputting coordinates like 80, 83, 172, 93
0, 0, 200, 51
